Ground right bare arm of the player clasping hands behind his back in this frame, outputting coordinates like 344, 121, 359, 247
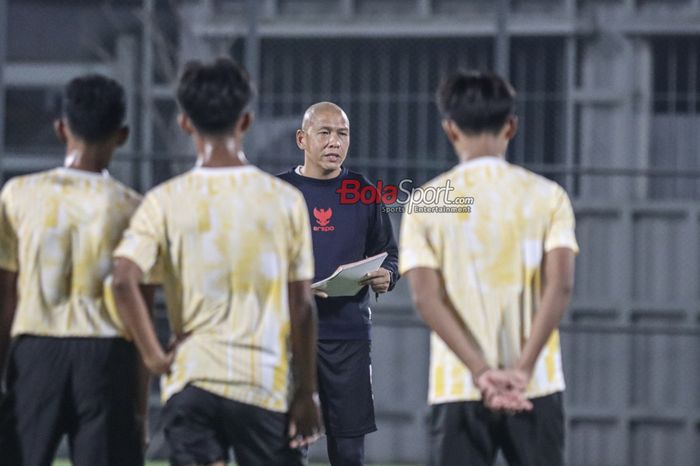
516, 247, 575, 381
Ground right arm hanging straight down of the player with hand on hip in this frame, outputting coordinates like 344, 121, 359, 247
288, 280, 322, 448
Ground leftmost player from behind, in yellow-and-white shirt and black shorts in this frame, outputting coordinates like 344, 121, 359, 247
0, 75, 145, 466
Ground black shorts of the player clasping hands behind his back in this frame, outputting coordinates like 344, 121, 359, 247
430, 392, 564, 466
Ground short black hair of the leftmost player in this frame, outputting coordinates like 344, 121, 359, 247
62, 74, 126, 143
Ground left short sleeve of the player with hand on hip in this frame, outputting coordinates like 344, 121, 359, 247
114, 193, 166, 283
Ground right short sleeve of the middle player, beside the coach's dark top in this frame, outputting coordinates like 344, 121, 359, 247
287, 194, 314, 282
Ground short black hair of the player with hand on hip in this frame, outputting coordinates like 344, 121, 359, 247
177, 58, 254, 135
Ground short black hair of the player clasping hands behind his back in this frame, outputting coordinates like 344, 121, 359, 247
437, 71, 515, 134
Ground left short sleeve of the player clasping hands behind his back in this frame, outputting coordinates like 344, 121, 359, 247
399, 212, 440, 275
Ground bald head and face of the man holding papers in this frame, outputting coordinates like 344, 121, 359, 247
297, 108, 350, 176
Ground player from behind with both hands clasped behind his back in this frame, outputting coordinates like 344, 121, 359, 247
399, 73, 578, 466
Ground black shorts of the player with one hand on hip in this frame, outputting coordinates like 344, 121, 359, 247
163, 385, 304, 466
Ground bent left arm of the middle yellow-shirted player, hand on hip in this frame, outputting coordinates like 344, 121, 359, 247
112, 257, 175, 374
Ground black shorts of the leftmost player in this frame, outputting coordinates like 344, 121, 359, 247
0, 336, 144, 466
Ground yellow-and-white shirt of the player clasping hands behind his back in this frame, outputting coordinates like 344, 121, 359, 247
399, 157, 578, 404
